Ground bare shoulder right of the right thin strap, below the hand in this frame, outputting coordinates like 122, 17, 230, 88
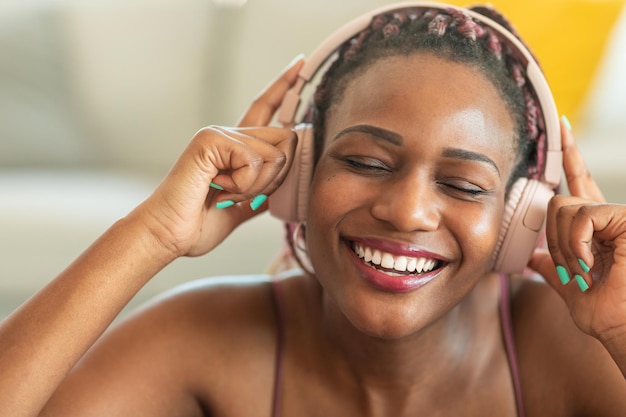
511, 279, 626, 416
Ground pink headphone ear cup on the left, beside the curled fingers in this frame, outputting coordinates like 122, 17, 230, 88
269, 123, 313, 222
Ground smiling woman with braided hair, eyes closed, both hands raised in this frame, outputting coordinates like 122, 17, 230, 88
0, 3, 626, 416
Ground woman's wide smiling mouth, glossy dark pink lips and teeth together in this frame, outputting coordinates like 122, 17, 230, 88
348, 237, 446, 292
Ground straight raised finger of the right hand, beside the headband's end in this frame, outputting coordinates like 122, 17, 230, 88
561, 119, 605, 202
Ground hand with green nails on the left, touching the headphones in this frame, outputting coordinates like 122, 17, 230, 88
135, 59, 303, 259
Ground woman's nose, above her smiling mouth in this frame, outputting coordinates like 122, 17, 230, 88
371, 172, 438, 232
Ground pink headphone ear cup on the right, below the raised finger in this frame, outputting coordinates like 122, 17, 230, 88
493, 178, 554, 274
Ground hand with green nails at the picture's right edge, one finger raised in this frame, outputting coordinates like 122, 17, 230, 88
529, 118, 626, 342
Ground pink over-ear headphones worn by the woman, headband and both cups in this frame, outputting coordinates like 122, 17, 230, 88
269, 2, 563, 273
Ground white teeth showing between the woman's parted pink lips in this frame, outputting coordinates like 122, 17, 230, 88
351, 242, 443, 276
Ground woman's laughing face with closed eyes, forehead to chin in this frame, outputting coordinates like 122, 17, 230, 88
307, 53, 515, 338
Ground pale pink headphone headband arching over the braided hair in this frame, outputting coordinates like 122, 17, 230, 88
278, 2, 563, 188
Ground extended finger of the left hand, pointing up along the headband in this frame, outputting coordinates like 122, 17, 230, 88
237, 56, 304, 127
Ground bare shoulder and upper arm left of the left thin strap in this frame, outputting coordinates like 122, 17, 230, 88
44, 275, 298, 416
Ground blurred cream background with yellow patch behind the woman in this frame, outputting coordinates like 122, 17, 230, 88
0, 0, 626, 318
